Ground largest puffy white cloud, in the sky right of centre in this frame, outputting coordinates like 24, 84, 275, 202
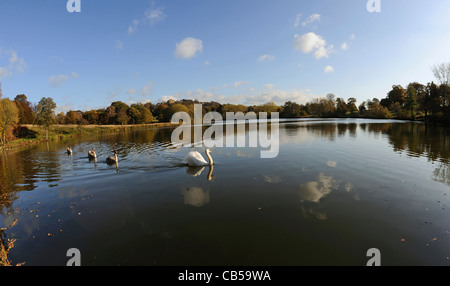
293, 32, 334, 59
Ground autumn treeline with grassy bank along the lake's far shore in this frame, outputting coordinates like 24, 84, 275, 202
0, 70, 450, 145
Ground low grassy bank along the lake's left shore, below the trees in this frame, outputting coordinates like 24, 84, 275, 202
0, 123, 178, 149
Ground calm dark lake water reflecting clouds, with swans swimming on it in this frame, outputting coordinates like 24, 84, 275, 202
0, 119, 450, 266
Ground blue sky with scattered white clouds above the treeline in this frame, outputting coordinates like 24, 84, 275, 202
0, 0, 450, 112
